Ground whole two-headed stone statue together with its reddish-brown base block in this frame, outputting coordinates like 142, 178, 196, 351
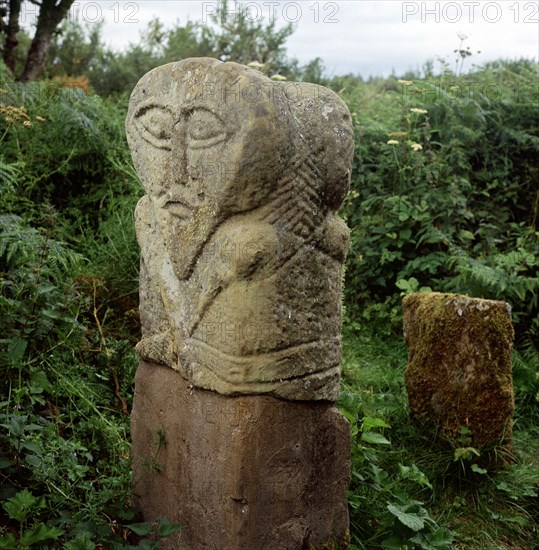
127, 58, 353, 550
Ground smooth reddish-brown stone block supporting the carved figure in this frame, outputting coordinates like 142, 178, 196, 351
131, 362, 350, 550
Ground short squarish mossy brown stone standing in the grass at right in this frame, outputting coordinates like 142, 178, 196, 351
403, 293, 514, 449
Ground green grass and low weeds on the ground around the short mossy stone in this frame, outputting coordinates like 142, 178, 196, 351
340, 328, 539, 550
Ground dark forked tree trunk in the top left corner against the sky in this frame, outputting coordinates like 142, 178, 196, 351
0, 0, 74, 82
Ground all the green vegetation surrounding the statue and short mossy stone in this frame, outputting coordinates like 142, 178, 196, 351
0, 7, 539, 550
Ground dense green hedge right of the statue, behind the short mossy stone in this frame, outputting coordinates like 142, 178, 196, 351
343, 61, 539, 344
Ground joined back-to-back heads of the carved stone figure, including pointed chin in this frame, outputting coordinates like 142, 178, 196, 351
126, 58, 353, 278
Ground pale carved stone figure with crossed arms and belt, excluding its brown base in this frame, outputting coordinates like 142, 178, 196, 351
126, 58, 353, 400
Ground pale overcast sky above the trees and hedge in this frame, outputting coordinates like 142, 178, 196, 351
26, 0, 539, 77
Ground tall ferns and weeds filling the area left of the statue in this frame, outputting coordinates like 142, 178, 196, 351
0, 62, 154, 548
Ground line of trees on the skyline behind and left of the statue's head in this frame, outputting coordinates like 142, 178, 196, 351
7, 0, 308, 96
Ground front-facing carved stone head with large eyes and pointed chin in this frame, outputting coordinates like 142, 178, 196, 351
126, 59, 291, 279
